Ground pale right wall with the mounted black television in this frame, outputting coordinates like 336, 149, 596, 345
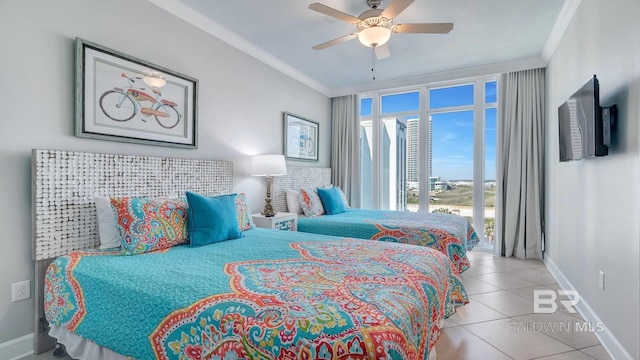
545, 0, 640, 359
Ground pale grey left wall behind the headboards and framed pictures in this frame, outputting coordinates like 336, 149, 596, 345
0, 0, 331, 344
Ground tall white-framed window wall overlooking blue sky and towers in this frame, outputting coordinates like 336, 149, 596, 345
360, 77, 497, 247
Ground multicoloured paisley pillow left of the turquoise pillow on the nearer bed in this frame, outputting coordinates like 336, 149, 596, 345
110, 197, 189, 255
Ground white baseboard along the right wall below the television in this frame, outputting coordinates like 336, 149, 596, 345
544, 256, 633, 360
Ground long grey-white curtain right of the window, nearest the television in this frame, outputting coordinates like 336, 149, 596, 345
493, 69, 545, 259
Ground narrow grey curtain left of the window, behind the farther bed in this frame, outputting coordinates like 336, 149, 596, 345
331, 95, 360, 207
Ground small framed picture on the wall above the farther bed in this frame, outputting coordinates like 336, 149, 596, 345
284, 112, 319, 161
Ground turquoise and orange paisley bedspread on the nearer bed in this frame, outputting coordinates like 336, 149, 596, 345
45, 229, 468, 359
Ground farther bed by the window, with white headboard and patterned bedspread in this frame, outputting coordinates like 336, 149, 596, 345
275, 166, 479, 273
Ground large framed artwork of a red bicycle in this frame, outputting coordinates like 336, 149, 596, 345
75, 38, 198, 148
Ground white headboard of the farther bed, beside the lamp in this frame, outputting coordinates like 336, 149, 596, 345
273, 166, 331, 212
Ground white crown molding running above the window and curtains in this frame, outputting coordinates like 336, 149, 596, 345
328, 57, 546, 97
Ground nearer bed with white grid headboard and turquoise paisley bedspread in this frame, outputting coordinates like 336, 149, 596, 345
33, 151, 468, 359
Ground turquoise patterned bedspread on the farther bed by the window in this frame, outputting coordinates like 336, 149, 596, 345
298, 209, 478, 274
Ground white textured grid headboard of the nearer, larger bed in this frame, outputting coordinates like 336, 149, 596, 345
32, 149, 233, 260
